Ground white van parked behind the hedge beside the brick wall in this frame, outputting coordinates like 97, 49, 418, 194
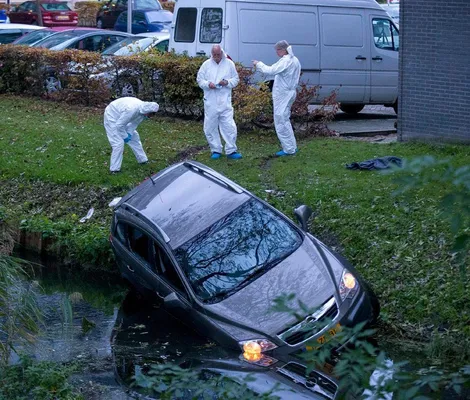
169, 0, 399, 113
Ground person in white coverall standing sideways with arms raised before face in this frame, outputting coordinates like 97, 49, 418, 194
253, 40, 300, 157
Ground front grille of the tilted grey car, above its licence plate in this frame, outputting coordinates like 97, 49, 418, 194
278, 297, 338, 346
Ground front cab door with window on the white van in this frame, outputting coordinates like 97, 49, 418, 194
369, 14, 400, 104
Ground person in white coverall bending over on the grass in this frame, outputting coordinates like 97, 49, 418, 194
104, 97, 159, 173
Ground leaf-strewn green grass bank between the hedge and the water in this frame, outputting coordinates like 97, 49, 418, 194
0, 96, 470, 356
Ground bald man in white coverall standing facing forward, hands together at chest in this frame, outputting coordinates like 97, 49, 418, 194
197, 45, 242, 160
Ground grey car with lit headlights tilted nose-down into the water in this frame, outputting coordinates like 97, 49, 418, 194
110, 162, 379, 363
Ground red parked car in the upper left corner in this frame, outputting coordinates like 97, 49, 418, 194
9, 0, 78, 26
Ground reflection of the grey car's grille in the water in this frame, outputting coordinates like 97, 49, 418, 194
277, 362, 338, 399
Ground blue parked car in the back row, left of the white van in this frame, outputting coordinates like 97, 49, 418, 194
114, 10, 173, 34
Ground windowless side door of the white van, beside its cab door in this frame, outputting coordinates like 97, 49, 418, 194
319, 7, 370, 104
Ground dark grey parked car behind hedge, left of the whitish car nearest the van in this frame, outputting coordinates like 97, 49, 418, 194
33, 28, 130, 52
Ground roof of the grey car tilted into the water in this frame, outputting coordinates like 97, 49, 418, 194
118, 162, 252, 249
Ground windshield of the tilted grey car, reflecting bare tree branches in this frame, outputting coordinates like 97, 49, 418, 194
175, 199, 302, 303
